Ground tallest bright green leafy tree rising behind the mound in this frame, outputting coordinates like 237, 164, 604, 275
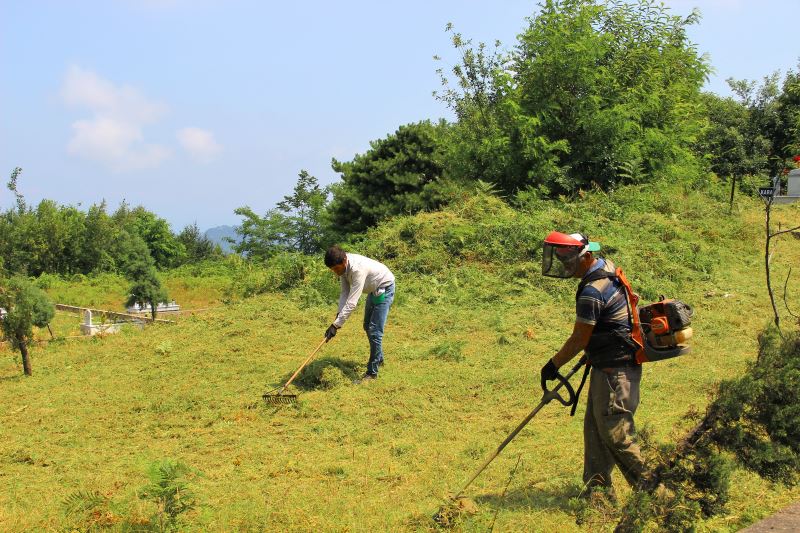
438, 0, 709, 194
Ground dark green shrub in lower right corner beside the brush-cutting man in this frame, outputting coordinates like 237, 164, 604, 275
618, 327, 800, 532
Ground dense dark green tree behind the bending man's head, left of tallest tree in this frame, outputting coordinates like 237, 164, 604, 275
329, 121, 454, 233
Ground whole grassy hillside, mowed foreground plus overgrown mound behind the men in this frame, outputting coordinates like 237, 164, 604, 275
0, 184, 800, 531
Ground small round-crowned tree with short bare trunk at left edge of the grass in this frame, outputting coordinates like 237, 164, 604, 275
0, 276, 55, 376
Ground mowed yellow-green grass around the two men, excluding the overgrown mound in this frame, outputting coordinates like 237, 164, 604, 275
0, 197, 800, 531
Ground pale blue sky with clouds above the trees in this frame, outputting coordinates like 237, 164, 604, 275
0, 0, 800, 231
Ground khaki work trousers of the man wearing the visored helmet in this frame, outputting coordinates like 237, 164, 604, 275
583, 365, 644, 492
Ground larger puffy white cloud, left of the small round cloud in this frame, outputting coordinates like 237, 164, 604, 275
61, 65, 170, 172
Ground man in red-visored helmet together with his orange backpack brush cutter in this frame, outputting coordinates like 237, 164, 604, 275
433, 231, 694, 525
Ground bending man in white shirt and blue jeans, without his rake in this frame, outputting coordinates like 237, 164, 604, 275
325, 246, 394, 380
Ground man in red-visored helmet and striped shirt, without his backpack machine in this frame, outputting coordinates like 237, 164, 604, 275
541, 231, 644, 500
